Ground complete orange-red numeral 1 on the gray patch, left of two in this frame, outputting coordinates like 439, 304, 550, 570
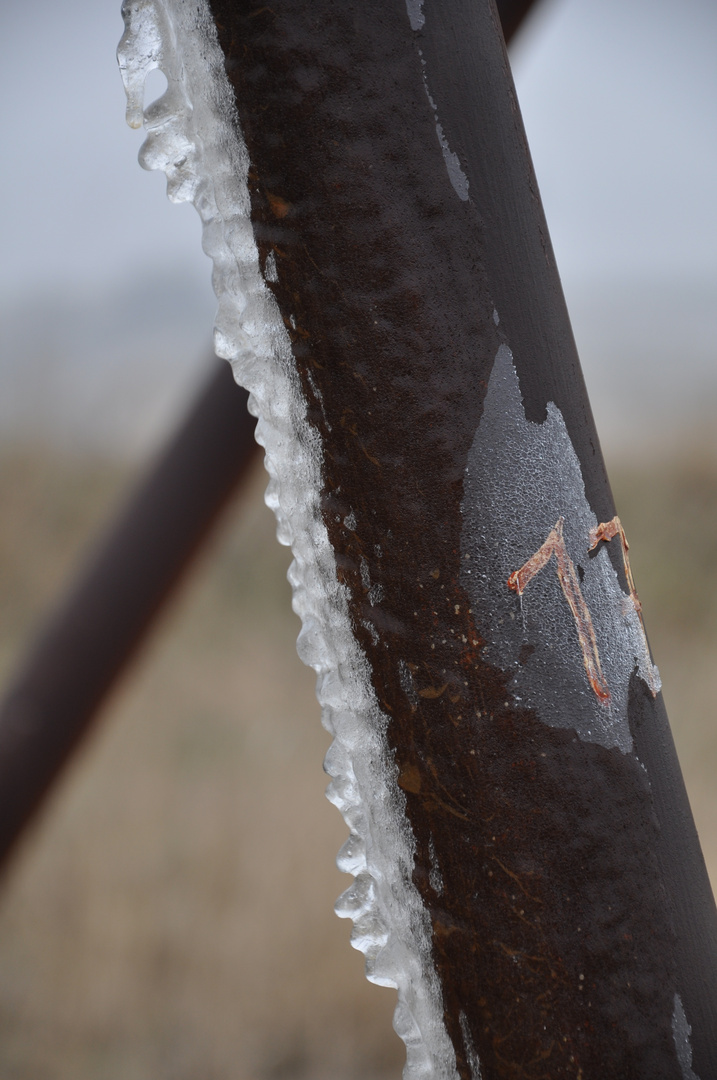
508, 517, 610, 705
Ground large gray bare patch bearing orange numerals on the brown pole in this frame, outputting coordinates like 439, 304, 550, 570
461, 346, 660, 753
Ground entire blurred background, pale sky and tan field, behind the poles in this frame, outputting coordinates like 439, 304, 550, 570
0, 0, 717, 1080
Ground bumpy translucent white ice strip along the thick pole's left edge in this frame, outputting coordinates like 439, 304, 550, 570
119, 0, 457, 1080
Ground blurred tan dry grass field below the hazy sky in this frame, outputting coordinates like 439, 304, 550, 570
0, 434, 717, 1080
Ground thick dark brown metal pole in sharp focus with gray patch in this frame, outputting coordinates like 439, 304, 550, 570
199, 0, 717, 1080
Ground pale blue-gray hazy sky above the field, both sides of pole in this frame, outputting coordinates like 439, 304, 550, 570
0, 0, 717, 455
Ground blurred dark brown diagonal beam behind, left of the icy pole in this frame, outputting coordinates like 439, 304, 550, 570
0, 357, 259, 863
